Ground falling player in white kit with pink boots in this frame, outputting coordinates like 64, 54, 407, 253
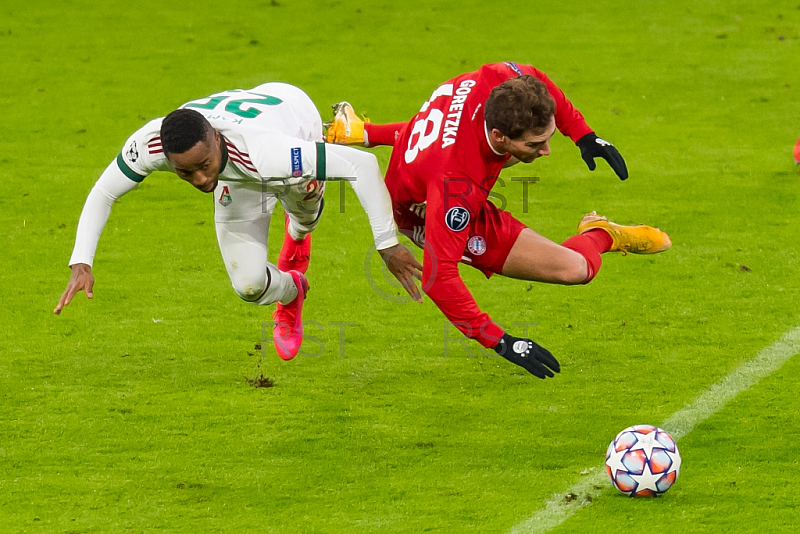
54, 83, 421, 359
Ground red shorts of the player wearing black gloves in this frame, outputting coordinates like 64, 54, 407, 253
393, 201, 527, 278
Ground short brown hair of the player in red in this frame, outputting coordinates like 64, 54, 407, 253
483, 74, 556, 139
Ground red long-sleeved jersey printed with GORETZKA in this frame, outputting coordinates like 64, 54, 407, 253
386, 62, 592, 348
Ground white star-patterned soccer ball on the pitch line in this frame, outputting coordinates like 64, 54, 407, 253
606, 425, 681, 497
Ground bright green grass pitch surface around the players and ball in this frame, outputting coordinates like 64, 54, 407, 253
0, 0, 800, 534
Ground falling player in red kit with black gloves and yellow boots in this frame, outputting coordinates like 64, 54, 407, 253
328, 62, 671, 378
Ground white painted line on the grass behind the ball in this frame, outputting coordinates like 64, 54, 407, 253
508, 326, 800, 534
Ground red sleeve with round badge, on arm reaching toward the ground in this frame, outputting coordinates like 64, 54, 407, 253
422, 176, 503, 348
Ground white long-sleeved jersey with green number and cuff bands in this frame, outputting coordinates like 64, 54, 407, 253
70, 83, 397, 265
